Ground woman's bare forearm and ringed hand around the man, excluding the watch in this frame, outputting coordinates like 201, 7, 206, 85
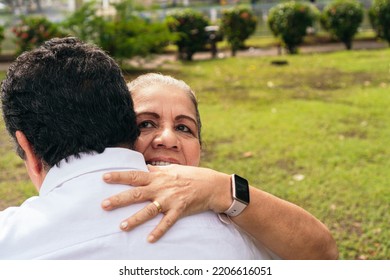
102, 165, 338, 259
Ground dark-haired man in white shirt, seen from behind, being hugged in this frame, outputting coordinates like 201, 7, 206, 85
0, 38, 261, 259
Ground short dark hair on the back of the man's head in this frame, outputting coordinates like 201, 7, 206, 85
1, 37, 139, 167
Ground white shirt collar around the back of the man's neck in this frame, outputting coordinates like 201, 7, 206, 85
39, 148, 148, 196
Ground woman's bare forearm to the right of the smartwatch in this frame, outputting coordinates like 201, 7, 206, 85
231, 187, 338, 259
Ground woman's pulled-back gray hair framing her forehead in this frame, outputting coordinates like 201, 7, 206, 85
127, 73, 202, 145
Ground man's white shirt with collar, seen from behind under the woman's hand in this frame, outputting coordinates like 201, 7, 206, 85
0, 148, 270, 260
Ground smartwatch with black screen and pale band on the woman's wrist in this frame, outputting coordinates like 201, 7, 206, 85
224, 174, 249, 217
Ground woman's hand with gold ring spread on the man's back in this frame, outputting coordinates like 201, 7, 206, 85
102, 164, 231, 242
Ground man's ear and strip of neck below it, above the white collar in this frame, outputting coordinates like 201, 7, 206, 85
15, 130, 46, 190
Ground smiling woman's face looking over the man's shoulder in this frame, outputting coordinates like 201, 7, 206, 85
132, 84, 200, 166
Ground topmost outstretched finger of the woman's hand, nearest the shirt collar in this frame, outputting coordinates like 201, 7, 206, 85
103, 171, 150, 186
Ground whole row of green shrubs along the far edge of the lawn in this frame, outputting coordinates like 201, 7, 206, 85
0, 0, 390, 60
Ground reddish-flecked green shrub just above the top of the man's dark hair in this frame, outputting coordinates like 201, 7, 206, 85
12, 16, 66, 54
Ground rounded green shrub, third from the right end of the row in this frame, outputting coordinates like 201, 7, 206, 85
268, 1, 319, 54
